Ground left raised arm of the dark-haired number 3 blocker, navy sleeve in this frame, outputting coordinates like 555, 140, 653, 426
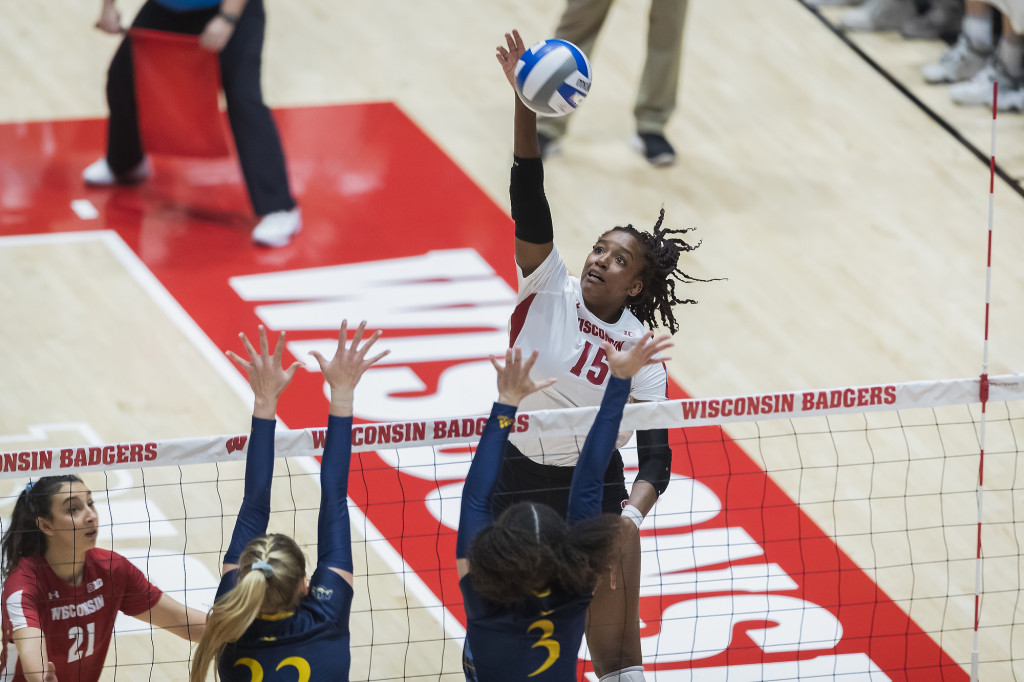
456, 348, 555, 578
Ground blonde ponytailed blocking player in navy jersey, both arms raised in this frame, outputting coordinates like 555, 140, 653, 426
190, 322, 387, 682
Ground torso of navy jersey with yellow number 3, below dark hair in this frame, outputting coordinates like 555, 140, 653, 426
459, 573, 594, 682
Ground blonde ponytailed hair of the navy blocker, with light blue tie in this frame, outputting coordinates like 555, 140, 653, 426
188, 534, 306, 682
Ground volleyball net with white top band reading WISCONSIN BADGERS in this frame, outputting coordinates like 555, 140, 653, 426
0, 375, 1024, 682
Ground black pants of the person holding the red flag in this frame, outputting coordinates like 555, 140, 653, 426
106, 0, 295, 215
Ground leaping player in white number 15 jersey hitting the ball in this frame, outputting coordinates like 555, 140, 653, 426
496, 31, 702, 682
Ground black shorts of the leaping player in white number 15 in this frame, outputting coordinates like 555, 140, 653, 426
490, 442, 629, 517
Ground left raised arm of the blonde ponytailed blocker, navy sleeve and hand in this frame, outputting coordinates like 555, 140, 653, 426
223, 325, 302, 573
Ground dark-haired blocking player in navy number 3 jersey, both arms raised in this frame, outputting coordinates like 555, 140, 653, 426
456, 333, 671, 682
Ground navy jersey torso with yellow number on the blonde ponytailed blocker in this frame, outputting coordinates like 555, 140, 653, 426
217, 567, 353, 682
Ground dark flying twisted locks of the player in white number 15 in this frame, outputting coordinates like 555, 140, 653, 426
608, 209, 713, 334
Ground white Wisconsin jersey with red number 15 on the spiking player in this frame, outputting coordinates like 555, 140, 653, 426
509, 249, 669, 466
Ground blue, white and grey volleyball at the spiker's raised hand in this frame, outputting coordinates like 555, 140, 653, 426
515, 38, 593, 116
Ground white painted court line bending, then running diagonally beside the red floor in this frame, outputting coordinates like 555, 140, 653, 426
0, 229, 466, 641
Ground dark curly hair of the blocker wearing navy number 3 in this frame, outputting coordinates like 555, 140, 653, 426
466, 502, 620, 606
